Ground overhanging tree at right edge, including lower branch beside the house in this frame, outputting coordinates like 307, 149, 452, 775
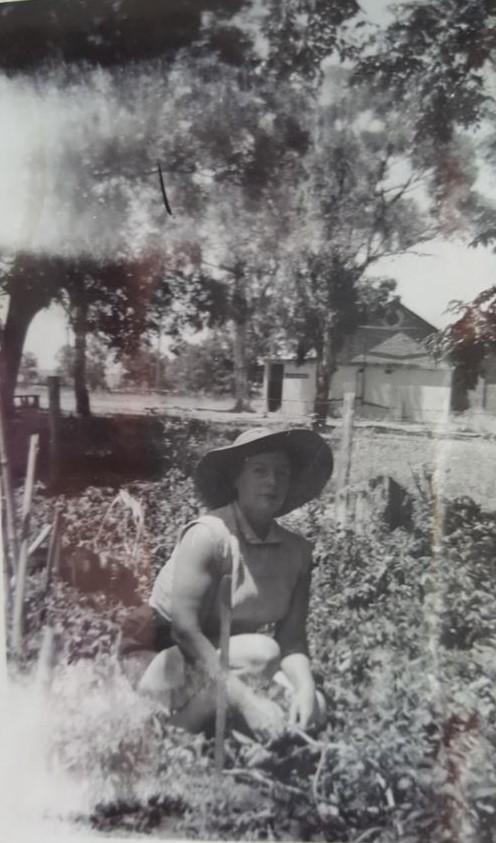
355, 0, 496, 410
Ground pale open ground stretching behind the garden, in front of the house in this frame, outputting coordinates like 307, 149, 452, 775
15, 388, 496, 509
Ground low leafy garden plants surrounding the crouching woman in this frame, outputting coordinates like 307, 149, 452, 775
9, 421, 496, 843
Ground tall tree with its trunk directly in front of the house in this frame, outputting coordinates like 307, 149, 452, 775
285, 84, 435, 427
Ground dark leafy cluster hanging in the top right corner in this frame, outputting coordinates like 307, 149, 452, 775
357, 0, 495, 145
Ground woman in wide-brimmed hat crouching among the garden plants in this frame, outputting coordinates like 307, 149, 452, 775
123, 428, 332, 736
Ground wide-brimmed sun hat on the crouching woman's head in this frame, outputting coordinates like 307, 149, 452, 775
195, 427, 333, 515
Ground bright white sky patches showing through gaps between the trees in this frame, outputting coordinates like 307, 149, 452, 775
0, 0, 496, 369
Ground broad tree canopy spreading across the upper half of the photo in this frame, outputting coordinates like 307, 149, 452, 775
0, 0, 496, 418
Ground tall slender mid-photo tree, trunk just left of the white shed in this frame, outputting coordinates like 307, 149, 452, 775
157, 62, 308, 411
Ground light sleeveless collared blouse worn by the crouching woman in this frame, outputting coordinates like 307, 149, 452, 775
149, 503, 311, 634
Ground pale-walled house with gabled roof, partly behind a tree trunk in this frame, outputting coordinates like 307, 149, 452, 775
264, 303, 464, 421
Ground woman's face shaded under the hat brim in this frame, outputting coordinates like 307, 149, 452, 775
234, 451, 291, 519
